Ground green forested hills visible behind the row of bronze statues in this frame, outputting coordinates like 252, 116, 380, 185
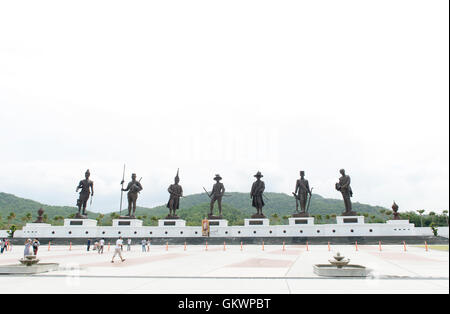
0, 192, 386, 225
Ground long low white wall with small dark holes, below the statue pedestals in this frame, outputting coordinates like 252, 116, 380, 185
14, 221, 420, 238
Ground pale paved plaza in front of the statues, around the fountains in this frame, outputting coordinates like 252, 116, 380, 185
0, 245, 449, 294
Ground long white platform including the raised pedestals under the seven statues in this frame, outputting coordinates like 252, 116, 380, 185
14, 216, 440, 239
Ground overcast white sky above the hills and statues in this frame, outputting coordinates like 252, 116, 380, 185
0, 0, 449, 212
